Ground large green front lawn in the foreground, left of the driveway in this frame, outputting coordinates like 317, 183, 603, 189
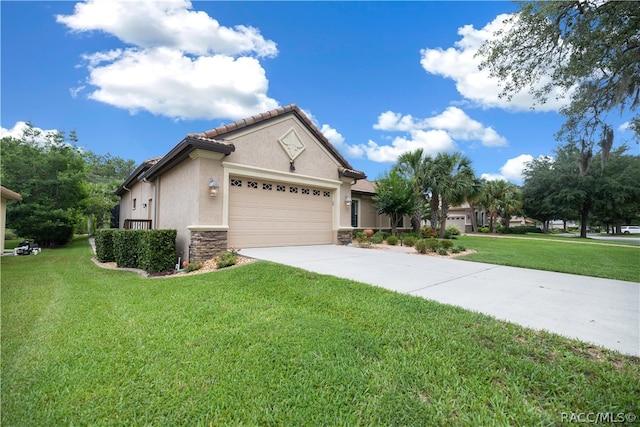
0, 239, 640, 426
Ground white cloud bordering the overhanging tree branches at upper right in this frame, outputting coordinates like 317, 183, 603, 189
420, 14, 565, 111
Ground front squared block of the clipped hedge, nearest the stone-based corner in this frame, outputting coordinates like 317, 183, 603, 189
138, 230, 178, 273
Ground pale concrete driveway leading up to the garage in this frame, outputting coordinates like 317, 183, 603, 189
242, 245, 640, 356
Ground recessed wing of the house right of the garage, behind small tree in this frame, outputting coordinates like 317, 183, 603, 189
351, 179, 411, 231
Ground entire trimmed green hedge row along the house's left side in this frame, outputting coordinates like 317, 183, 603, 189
95, 229, 178, 273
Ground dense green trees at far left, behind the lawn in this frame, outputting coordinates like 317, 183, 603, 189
0, 124, 135, 247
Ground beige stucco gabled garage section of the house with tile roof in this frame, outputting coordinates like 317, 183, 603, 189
117, 104, 365, 262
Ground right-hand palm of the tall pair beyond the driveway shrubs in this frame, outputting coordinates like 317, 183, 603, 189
432, 152, 478, 237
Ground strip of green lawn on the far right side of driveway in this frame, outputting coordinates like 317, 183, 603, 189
456, 234, 640, 282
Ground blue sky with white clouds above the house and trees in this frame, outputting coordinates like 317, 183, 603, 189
0, 0, 633, 183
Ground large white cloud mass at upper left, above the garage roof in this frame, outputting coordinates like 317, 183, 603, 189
57, 0, 278, 119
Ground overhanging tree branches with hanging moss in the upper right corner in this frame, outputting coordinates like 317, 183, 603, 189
477, 0, 640, 139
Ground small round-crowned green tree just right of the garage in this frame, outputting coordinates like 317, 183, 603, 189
373, 169, 415, 235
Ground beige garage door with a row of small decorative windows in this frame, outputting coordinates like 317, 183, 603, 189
228, 177, 333, 248
